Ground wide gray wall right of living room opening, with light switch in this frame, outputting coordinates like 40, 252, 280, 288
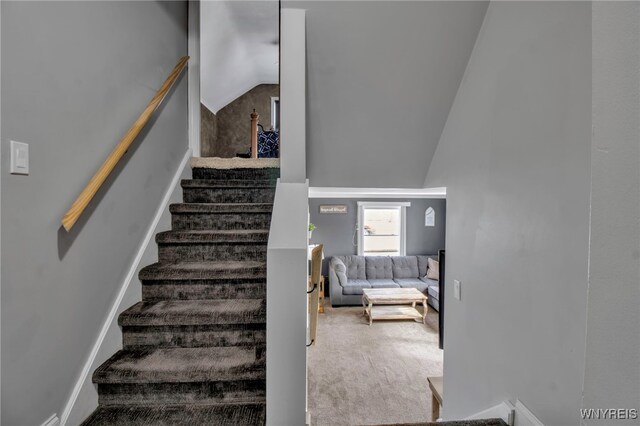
426, 2, 592, 425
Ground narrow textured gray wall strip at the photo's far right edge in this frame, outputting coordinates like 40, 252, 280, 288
582, 2, 640, 424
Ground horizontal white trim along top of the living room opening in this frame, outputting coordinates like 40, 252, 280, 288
309, 186, 447, 198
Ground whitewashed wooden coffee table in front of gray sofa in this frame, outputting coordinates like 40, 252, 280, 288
362, 288, 428, 325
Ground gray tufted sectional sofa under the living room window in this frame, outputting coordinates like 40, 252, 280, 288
329, 255, 440, 310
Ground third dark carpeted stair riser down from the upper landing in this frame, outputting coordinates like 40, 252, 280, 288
171, 213, 271, 231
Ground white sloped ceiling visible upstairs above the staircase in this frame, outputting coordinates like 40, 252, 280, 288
200, 0, 279, 113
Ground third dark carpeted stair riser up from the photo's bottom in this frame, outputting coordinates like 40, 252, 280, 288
142, 281, 267, 302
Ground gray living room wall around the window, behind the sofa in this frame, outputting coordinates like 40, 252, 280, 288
309, 198, 446, 276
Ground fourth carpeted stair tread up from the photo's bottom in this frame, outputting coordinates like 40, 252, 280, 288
139, 260, 267, 280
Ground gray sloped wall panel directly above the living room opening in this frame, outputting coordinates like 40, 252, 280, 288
282, 1, 487, 188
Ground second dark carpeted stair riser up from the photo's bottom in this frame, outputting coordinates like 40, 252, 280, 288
122, 325, 266, 349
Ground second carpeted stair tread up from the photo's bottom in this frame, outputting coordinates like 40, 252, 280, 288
93, 346, 265, 384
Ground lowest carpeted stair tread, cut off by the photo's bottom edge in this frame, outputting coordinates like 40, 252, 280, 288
82, 403, 266, 426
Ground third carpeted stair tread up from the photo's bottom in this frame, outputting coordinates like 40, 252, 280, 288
118, 299, 266, 326
